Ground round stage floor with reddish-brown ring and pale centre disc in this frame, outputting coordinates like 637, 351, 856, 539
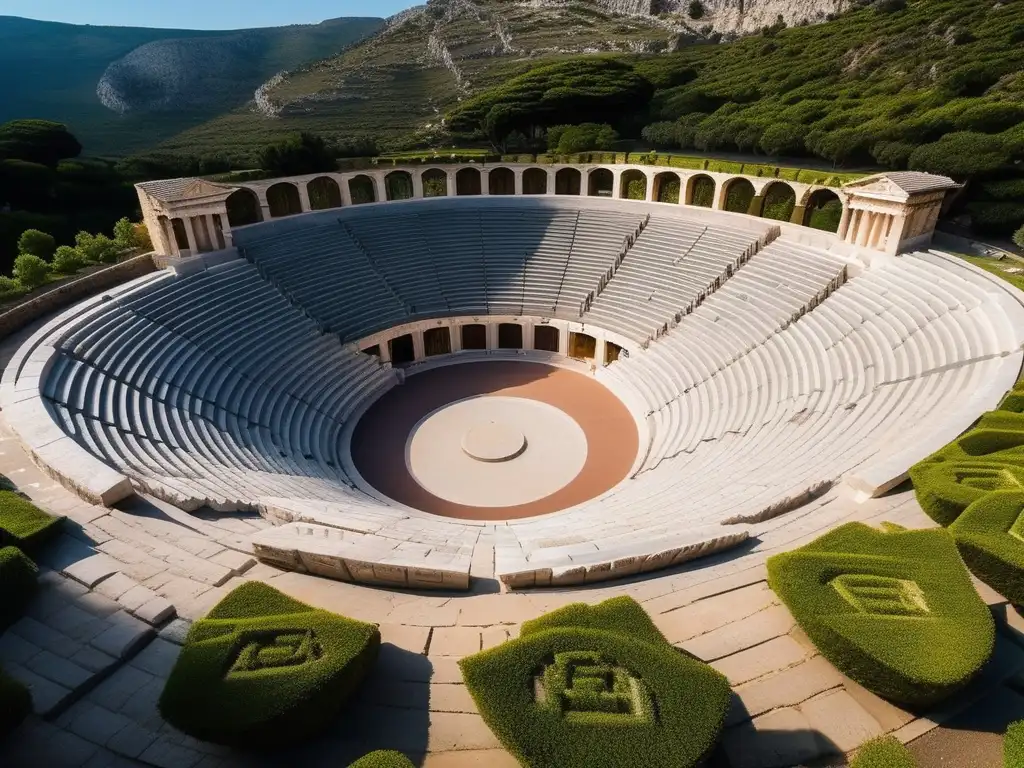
351, 361, 639, 520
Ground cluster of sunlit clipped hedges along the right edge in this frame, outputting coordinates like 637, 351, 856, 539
910, 397, 1024, 605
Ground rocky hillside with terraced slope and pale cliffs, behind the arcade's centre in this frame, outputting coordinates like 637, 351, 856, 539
155, 0, 870, 159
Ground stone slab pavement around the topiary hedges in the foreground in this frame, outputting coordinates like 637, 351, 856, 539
0, 405, 1024, 768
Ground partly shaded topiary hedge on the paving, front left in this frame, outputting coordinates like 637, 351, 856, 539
160, 582, 380, 746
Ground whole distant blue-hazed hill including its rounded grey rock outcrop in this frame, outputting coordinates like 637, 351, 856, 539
0, 16, 383, 155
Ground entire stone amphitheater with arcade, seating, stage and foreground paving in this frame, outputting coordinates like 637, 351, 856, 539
0, 159, 1024, 768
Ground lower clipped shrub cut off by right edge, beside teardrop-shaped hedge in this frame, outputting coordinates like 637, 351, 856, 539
949, 490, 1024, 605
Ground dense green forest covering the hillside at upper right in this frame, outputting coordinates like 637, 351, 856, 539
446, 0, 1024, 234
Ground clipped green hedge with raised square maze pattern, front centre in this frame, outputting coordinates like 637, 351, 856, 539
460, 597, 729, 768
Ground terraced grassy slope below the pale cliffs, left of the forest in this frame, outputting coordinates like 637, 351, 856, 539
155, 0, 671, 159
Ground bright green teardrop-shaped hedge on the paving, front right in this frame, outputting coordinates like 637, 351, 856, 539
768, 523, 995, 706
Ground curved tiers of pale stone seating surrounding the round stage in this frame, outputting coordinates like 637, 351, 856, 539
2, 185, 1024, 588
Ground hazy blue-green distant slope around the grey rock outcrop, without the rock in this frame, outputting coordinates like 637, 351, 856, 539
0, 16, 380, 155
